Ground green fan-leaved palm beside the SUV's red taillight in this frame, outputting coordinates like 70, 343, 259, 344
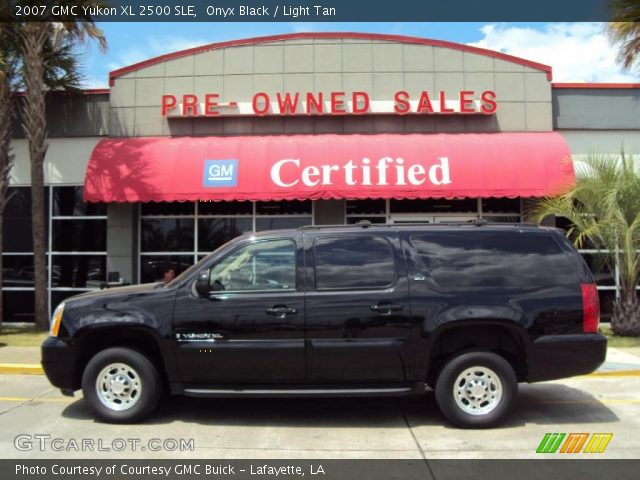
534, 153, 640, 336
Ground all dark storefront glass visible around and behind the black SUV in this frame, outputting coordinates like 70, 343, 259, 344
2, 190, 632, 321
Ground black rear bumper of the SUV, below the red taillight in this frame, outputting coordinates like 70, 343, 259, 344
527, 333, 607, 382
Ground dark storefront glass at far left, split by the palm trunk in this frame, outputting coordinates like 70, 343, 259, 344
2, 186, 107, 321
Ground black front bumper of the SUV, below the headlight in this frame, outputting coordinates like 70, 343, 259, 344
41, 337, 82, 393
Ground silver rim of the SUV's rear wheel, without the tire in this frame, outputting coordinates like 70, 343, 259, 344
453, 367, 503, 415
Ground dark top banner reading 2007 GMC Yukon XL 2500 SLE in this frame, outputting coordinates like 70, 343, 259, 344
1, 0, 611, 22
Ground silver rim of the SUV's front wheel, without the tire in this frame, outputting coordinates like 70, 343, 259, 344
96, 363, 142, 411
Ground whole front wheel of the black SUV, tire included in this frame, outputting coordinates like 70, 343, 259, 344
82, 347, 162, 423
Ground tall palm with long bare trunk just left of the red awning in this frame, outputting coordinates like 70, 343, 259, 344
19, 0, 106, 329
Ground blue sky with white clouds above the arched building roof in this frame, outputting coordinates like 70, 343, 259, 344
82, 22, 640, 88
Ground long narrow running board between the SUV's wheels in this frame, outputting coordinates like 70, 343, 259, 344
183, 382, 425, 398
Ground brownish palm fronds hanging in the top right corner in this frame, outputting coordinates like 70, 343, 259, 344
607, 0, 640, 68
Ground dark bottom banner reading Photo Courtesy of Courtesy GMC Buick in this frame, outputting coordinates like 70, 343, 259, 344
0, 459, 640, 480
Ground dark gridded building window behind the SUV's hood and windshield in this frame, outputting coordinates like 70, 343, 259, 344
139, 200, 313, 283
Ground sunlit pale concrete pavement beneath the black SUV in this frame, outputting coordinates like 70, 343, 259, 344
0, 374, 640, 459
